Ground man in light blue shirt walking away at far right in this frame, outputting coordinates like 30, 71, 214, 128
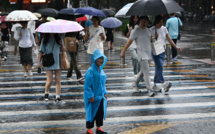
166, 13, 183, 64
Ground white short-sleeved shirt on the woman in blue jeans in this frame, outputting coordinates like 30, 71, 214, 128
150, 26, 168, 47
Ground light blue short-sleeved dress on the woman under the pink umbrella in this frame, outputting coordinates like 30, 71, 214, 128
40, 37, 61, 70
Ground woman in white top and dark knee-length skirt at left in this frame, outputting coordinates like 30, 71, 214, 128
14, 21, 37, 77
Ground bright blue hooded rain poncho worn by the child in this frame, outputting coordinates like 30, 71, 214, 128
84, 49, 107, 122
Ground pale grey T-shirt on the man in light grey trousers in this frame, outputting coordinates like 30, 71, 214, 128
129, 26, 152, 61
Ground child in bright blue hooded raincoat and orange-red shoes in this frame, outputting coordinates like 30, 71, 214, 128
84, 49, 107, 134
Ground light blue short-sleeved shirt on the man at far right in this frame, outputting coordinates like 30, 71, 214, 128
166, 17, 183, 39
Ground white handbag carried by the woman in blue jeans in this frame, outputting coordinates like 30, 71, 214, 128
151, 40, 165, 55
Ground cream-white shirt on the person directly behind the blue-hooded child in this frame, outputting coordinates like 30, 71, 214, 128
87, 25, 106, 54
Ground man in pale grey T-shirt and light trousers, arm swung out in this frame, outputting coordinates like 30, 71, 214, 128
120, 16, 155, 97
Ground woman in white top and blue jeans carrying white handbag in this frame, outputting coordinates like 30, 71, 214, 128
151, 15, 182, 92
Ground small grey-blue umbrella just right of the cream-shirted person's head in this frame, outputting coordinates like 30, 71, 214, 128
100, 17, 122, 28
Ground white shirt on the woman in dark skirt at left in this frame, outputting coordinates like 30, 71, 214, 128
14, 28, 36, 48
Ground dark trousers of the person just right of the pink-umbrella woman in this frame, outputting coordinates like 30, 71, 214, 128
67, 52, 82, 79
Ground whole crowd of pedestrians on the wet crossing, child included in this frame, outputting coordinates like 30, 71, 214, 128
0, 9, 182, 134
